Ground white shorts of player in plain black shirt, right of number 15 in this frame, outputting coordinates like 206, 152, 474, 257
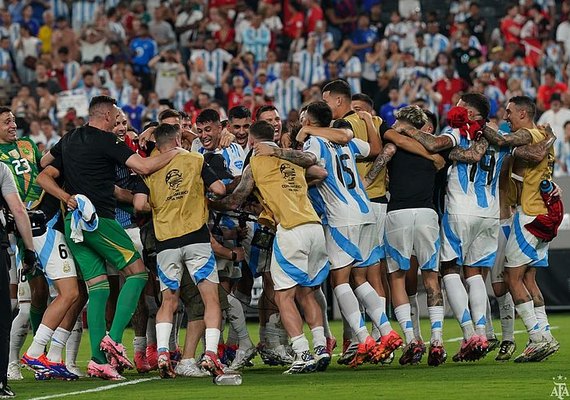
384, 208, 440, 273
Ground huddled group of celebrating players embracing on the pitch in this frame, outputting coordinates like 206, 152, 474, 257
0, 80, 560, 380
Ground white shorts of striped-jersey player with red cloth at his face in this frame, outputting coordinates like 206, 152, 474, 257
440, 212, 499, 268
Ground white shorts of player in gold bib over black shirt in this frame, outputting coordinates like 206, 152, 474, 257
156, 243, 220, 291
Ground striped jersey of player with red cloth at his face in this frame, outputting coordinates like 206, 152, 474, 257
442, 127, 509, 218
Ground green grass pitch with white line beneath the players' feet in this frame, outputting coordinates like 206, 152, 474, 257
10, 314, 570, 400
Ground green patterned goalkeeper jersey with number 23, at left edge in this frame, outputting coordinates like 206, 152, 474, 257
0, 138, 42, 209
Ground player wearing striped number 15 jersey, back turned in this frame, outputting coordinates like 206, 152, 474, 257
256, 101, 384, 368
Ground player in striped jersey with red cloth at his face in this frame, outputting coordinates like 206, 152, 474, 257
404, 93, 506, 361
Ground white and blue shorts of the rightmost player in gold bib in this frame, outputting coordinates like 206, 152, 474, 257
505, 206, 549, 268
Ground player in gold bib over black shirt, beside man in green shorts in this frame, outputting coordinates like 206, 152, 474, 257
134, 124, 225, 378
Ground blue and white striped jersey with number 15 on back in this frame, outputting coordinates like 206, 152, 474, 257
303, 136, 375, 227
